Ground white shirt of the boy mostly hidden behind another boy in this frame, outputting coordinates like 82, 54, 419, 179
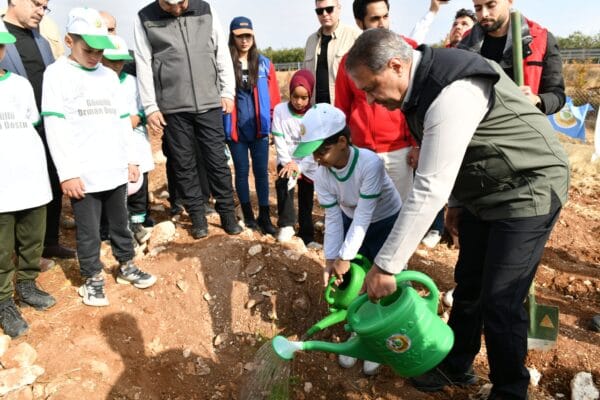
120, 72, 154, 174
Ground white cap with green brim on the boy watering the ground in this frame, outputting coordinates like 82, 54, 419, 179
294, 103, 346, 158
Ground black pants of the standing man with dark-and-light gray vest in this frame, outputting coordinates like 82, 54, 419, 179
165, 108, 234, 220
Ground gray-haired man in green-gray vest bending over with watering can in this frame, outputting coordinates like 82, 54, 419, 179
346, 29, 569, 400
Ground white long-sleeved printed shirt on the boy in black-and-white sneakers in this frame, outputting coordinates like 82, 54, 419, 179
42, 57, 139, 193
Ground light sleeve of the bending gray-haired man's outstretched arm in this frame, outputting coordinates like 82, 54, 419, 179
375, 78, 493, 274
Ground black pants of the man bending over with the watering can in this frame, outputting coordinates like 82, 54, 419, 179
443, 198, 560, 399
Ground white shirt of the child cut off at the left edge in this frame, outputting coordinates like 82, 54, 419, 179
0, 71, 52, 213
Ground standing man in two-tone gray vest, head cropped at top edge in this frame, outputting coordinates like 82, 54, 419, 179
134, 0, 242, 239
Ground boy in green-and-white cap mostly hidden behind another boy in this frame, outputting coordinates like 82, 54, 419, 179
102, 35, 154, 245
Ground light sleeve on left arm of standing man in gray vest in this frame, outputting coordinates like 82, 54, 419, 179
133, 17, 160, 116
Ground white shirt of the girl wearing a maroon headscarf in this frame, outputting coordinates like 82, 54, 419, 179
271, 102, 318, 181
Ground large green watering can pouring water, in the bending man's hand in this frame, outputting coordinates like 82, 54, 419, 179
272, 271, 454, 377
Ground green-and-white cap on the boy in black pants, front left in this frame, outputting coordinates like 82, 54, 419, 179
67, 7, 115, 50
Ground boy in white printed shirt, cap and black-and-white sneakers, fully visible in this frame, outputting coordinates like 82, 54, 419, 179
42, 8, 156, 306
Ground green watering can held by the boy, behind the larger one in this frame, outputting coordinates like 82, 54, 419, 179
306, 254, 371, 337
